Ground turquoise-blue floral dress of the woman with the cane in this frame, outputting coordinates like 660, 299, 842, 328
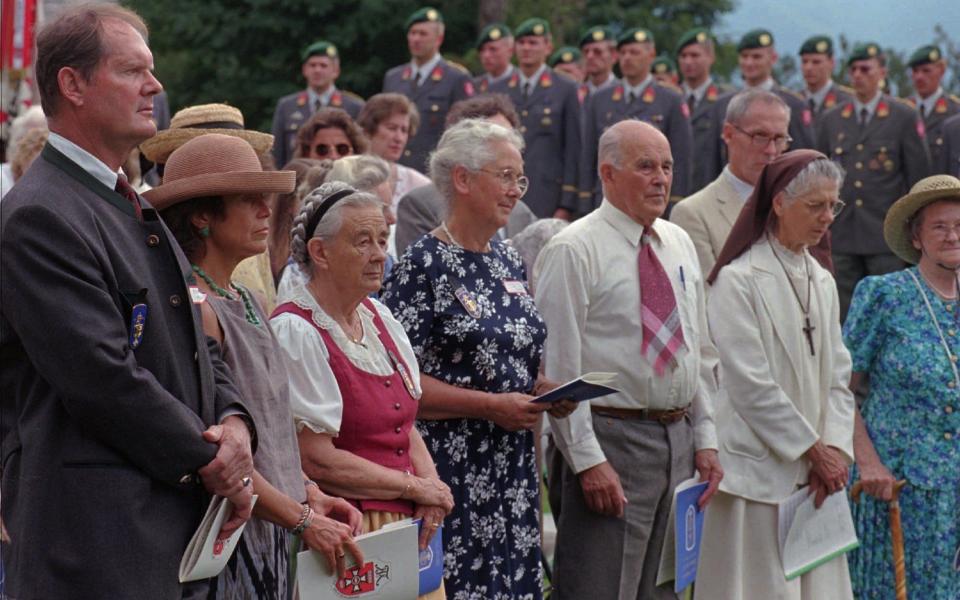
843, 268, 960, 600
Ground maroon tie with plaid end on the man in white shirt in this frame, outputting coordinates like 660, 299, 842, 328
637, 227, 684, 375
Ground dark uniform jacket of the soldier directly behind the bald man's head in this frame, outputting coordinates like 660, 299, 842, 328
580, 76, 693, 213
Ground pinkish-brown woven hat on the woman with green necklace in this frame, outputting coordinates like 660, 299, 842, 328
143, 133, 296, 210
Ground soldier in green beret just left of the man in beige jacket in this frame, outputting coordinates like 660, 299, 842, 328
677, 27, 733, 192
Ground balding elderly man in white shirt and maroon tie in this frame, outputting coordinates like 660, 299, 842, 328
536, 121, 723, 600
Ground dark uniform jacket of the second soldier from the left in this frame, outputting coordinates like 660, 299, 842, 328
383, 54, 473, 173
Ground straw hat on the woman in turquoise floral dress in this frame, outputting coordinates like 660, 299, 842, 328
883, 175, 960, 265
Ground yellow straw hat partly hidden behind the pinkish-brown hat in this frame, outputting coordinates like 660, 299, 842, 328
140, 104, 273, 163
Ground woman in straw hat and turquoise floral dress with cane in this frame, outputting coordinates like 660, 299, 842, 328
844, 175, 960, 600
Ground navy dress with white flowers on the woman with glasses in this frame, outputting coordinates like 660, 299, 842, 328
383, 235, 546, 600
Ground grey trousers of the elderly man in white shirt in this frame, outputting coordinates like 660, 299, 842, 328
552, 414, 694, 600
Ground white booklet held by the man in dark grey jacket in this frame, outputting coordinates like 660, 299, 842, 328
180, 495, 257, 583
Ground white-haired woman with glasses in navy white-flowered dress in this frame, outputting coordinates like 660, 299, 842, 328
383, 119, 570, 598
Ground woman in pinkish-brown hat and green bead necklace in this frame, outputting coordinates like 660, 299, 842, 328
145, 134, 360, 598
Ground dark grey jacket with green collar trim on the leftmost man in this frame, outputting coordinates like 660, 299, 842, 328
0, 145, 249, 600
